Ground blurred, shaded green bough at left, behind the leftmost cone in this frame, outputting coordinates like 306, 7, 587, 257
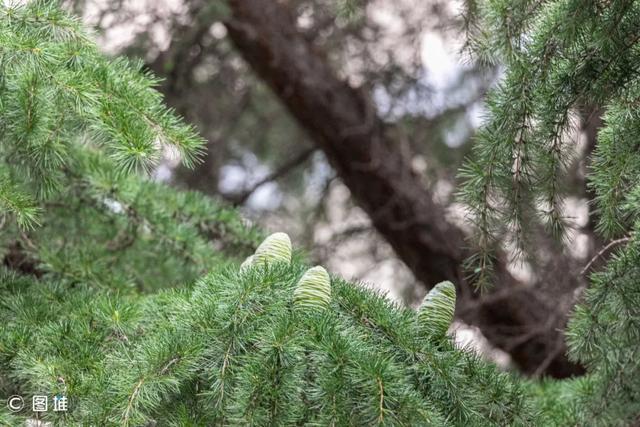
0, 151, 261, 292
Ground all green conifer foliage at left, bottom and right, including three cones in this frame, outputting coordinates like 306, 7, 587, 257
0, 0, 640, 426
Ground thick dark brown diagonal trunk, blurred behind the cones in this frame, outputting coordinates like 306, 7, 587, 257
218, 0, 581, 377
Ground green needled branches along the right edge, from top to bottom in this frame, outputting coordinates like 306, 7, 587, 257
461, 0, 640, 425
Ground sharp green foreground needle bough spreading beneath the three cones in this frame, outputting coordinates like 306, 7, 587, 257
0, 263, 536, 425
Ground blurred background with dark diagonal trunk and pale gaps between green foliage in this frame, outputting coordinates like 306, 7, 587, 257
58, 0, 606, 377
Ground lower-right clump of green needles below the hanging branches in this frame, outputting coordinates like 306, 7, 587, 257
568, 238, 640, 425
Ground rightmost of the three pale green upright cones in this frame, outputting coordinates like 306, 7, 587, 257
418, 281, 456, 338
